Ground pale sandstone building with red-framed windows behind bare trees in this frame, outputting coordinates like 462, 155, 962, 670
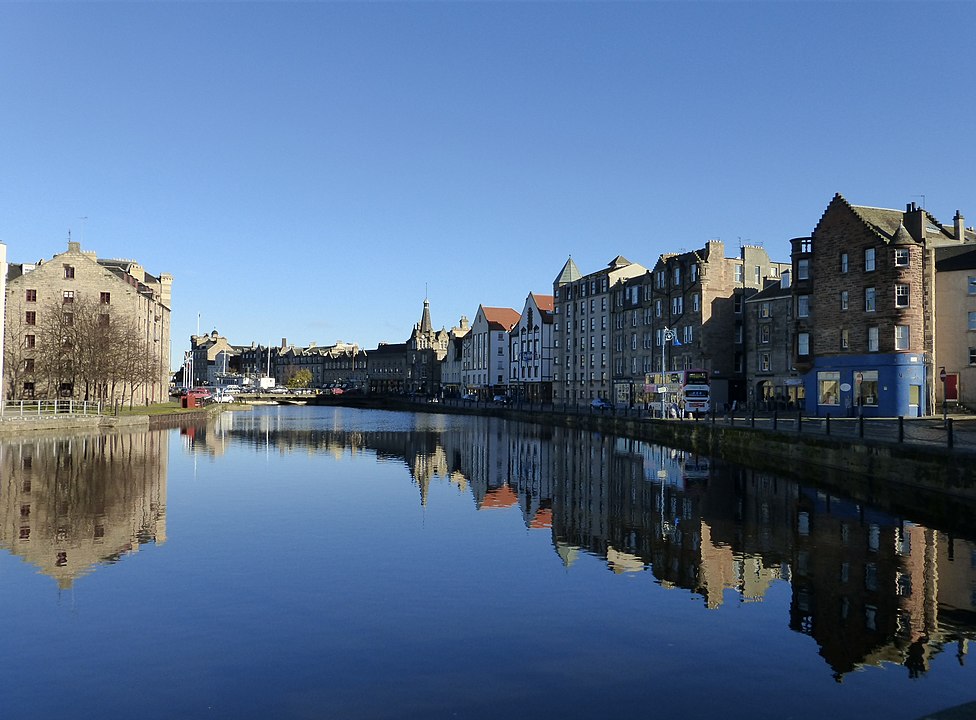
4, 241, 173, 404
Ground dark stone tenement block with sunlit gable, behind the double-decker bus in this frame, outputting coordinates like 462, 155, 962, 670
612, 240, 790, 407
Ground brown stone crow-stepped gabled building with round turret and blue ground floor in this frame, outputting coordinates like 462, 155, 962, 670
791, 194, 972, 417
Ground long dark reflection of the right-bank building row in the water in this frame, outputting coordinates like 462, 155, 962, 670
214, 414, 976, 680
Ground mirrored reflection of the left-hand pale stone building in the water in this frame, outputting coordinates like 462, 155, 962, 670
0, 432, 169, 589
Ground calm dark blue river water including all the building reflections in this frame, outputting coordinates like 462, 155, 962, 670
0, 408, 976, 720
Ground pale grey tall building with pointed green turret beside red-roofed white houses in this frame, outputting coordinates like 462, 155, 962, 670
552, 255, 647, 403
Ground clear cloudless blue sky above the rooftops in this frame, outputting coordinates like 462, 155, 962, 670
0, 2, 976, 368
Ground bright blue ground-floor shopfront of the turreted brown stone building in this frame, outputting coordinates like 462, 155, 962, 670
804, 353, 928, 417
